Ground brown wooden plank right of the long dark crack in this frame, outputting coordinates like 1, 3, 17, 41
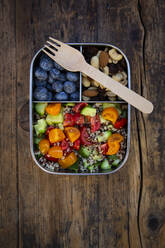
137, 0, 165, 248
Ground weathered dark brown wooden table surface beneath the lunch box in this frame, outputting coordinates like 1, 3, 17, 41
0, 0, 165, 248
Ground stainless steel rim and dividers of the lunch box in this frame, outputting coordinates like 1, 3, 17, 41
29, 43, 131, 175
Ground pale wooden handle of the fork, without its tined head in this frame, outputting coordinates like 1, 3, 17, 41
81, 63, 153, 114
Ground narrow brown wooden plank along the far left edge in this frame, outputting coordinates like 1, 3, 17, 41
0, 0, 19, 248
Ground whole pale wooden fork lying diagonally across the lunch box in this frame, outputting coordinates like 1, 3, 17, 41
42, 37, 153, 113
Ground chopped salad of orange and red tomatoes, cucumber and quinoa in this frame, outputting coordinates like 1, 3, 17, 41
33, 102, 127, 173
